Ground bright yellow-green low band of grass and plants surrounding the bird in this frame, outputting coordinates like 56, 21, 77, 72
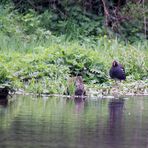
0, 37, 148, 94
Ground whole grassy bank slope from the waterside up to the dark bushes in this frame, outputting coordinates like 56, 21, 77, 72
0, 4, 148, 94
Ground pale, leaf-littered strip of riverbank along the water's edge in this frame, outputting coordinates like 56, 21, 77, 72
10, 81, 148, 99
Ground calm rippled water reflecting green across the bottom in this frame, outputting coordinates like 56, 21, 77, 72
0, 96, 148, 148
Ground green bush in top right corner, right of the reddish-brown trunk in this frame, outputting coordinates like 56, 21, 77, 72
120, 3, 148, 42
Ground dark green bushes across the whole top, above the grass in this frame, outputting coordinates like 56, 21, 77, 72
0, 0, 148, 43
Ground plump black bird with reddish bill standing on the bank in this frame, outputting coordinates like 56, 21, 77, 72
109, 60, 126, 81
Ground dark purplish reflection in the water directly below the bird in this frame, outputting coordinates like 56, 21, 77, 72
107, 99, 124, 148
